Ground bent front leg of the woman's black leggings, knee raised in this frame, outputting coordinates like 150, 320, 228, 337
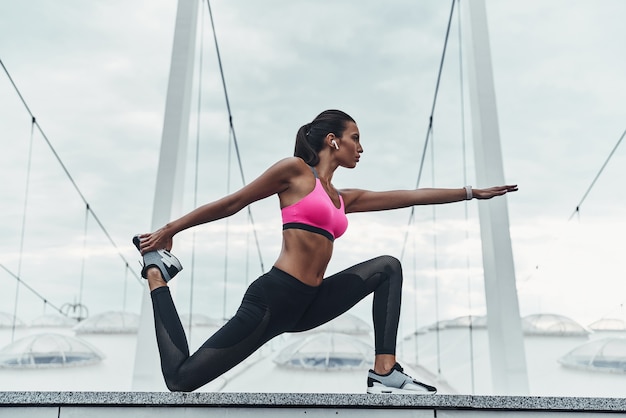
290, 256, 402, 354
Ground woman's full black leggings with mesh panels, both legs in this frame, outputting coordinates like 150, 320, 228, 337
151, 256, 402, 392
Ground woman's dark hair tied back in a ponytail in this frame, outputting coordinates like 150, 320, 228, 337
293, 110, 354, 166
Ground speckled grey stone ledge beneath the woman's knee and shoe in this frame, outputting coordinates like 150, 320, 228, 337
0, 392, 626, 412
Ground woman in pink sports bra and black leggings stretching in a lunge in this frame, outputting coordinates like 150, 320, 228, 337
133, 110, 517, 394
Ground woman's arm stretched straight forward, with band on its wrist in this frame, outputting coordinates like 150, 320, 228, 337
341, 185, 517, 213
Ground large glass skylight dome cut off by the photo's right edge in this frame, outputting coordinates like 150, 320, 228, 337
559, 338, 626, 373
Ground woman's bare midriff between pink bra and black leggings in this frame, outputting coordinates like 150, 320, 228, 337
274, 229, 333, 286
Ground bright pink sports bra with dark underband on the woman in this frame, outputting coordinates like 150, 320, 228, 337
281, 167, 348, 241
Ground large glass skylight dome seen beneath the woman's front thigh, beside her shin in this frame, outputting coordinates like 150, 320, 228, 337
274, 332, 374, 370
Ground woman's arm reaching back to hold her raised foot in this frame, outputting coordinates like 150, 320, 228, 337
141, 158, 301, 253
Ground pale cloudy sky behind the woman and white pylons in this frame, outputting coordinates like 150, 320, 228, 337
0, 0, 626, 336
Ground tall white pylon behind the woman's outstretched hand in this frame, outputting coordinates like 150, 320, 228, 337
463, 0, 529, 395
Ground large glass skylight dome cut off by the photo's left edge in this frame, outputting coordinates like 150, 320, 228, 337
0, 334, 103, 368
